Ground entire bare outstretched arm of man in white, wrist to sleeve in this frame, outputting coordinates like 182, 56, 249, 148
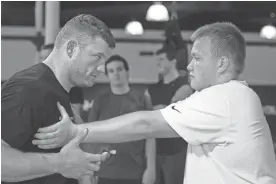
76, 110, 179, 143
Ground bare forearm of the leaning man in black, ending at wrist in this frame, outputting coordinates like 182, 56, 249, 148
1, 143, 60, 182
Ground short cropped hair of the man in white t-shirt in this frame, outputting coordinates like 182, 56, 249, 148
191, 22, 246, 74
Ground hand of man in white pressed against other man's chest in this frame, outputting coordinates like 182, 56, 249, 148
33, 103, 78, 149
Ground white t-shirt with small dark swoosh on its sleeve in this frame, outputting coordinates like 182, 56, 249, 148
161, 81, 276, 184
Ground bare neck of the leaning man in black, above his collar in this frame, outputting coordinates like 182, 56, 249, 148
43, 53, 73, 93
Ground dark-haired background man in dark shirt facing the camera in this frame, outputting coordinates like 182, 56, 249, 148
82, 55, 155, 184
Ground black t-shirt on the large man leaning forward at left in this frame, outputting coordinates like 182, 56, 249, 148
1, 63, 73, 184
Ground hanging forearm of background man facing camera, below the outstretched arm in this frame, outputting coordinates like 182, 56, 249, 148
145, 138, 156, 170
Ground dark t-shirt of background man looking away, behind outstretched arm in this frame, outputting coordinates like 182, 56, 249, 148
148, 77, 188, 155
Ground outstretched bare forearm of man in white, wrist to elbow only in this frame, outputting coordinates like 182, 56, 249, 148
77, 111, 150, 143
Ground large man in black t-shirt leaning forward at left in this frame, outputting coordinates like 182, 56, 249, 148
1, 14, 115, 184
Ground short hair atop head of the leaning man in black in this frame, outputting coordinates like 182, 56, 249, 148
55, 14, 116, 49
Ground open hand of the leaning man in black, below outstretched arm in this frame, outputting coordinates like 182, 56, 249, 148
57, 129, 110, 179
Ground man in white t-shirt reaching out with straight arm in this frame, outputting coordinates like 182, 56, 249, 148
33, 23, 276, 184
